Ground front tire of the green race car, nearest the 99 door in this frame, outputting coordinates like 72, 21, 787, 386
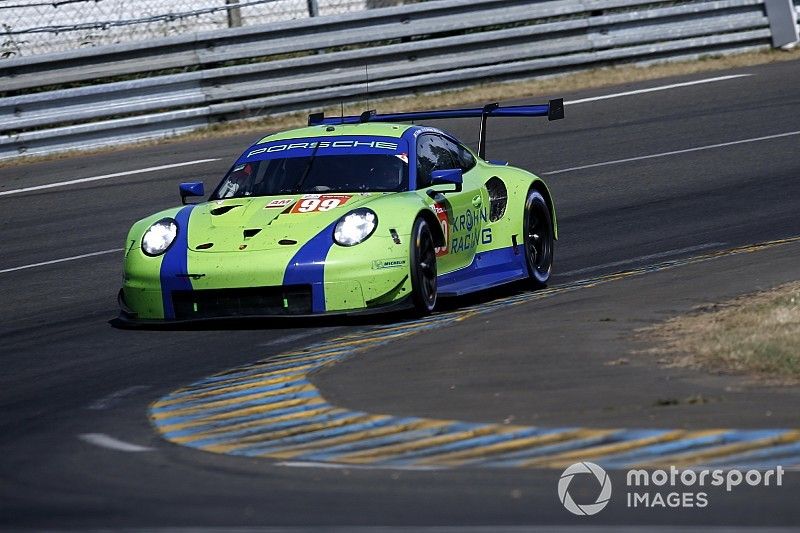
410, 218, 438, 315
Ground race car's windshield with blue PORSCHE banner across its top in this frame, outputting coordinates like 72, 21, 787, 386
211, 137, 408, 200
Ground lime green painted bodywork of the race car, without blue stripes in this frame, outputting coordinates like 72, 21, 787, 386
122, 123, 557, 320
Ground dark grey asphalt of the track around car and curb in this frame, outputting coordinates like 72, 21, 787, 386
0, 56, 800, 528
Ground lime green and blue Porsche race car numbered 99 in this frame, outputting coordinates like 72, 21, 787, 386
118, 100, 563, 322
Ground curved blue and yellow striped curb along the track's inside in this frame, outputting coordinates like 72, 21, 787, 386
150, 237, 800, 469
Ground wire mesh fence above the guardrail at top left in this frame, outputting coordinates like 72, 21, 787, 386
0, 0, 422, 58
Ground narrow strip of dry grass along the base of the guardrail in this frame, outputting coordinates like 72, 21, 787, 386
0, 48, 800, 168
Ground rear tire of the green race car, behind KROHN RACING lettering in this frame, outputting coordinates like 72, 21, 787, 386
522, 190, 554, 289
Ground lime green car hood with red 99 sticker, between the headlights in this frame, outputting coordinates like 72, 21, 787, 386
188, 193, 391, 253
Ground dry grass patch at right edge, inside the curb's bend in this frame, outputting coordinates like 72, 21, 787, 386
639, 282, 800, 384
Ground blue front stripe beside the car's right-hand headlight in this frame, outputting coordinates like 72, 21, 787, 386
283, 220, 339, 313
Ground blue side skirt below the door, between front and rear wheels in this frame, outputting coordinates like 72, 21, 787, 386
439, 244, 528, 296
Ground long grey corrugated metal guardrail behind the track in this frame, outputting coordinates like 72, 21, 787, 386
0, 0, 792, 158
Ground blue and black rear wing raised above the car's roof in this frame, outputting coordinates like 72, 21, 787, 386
308, 98, 564, 159
